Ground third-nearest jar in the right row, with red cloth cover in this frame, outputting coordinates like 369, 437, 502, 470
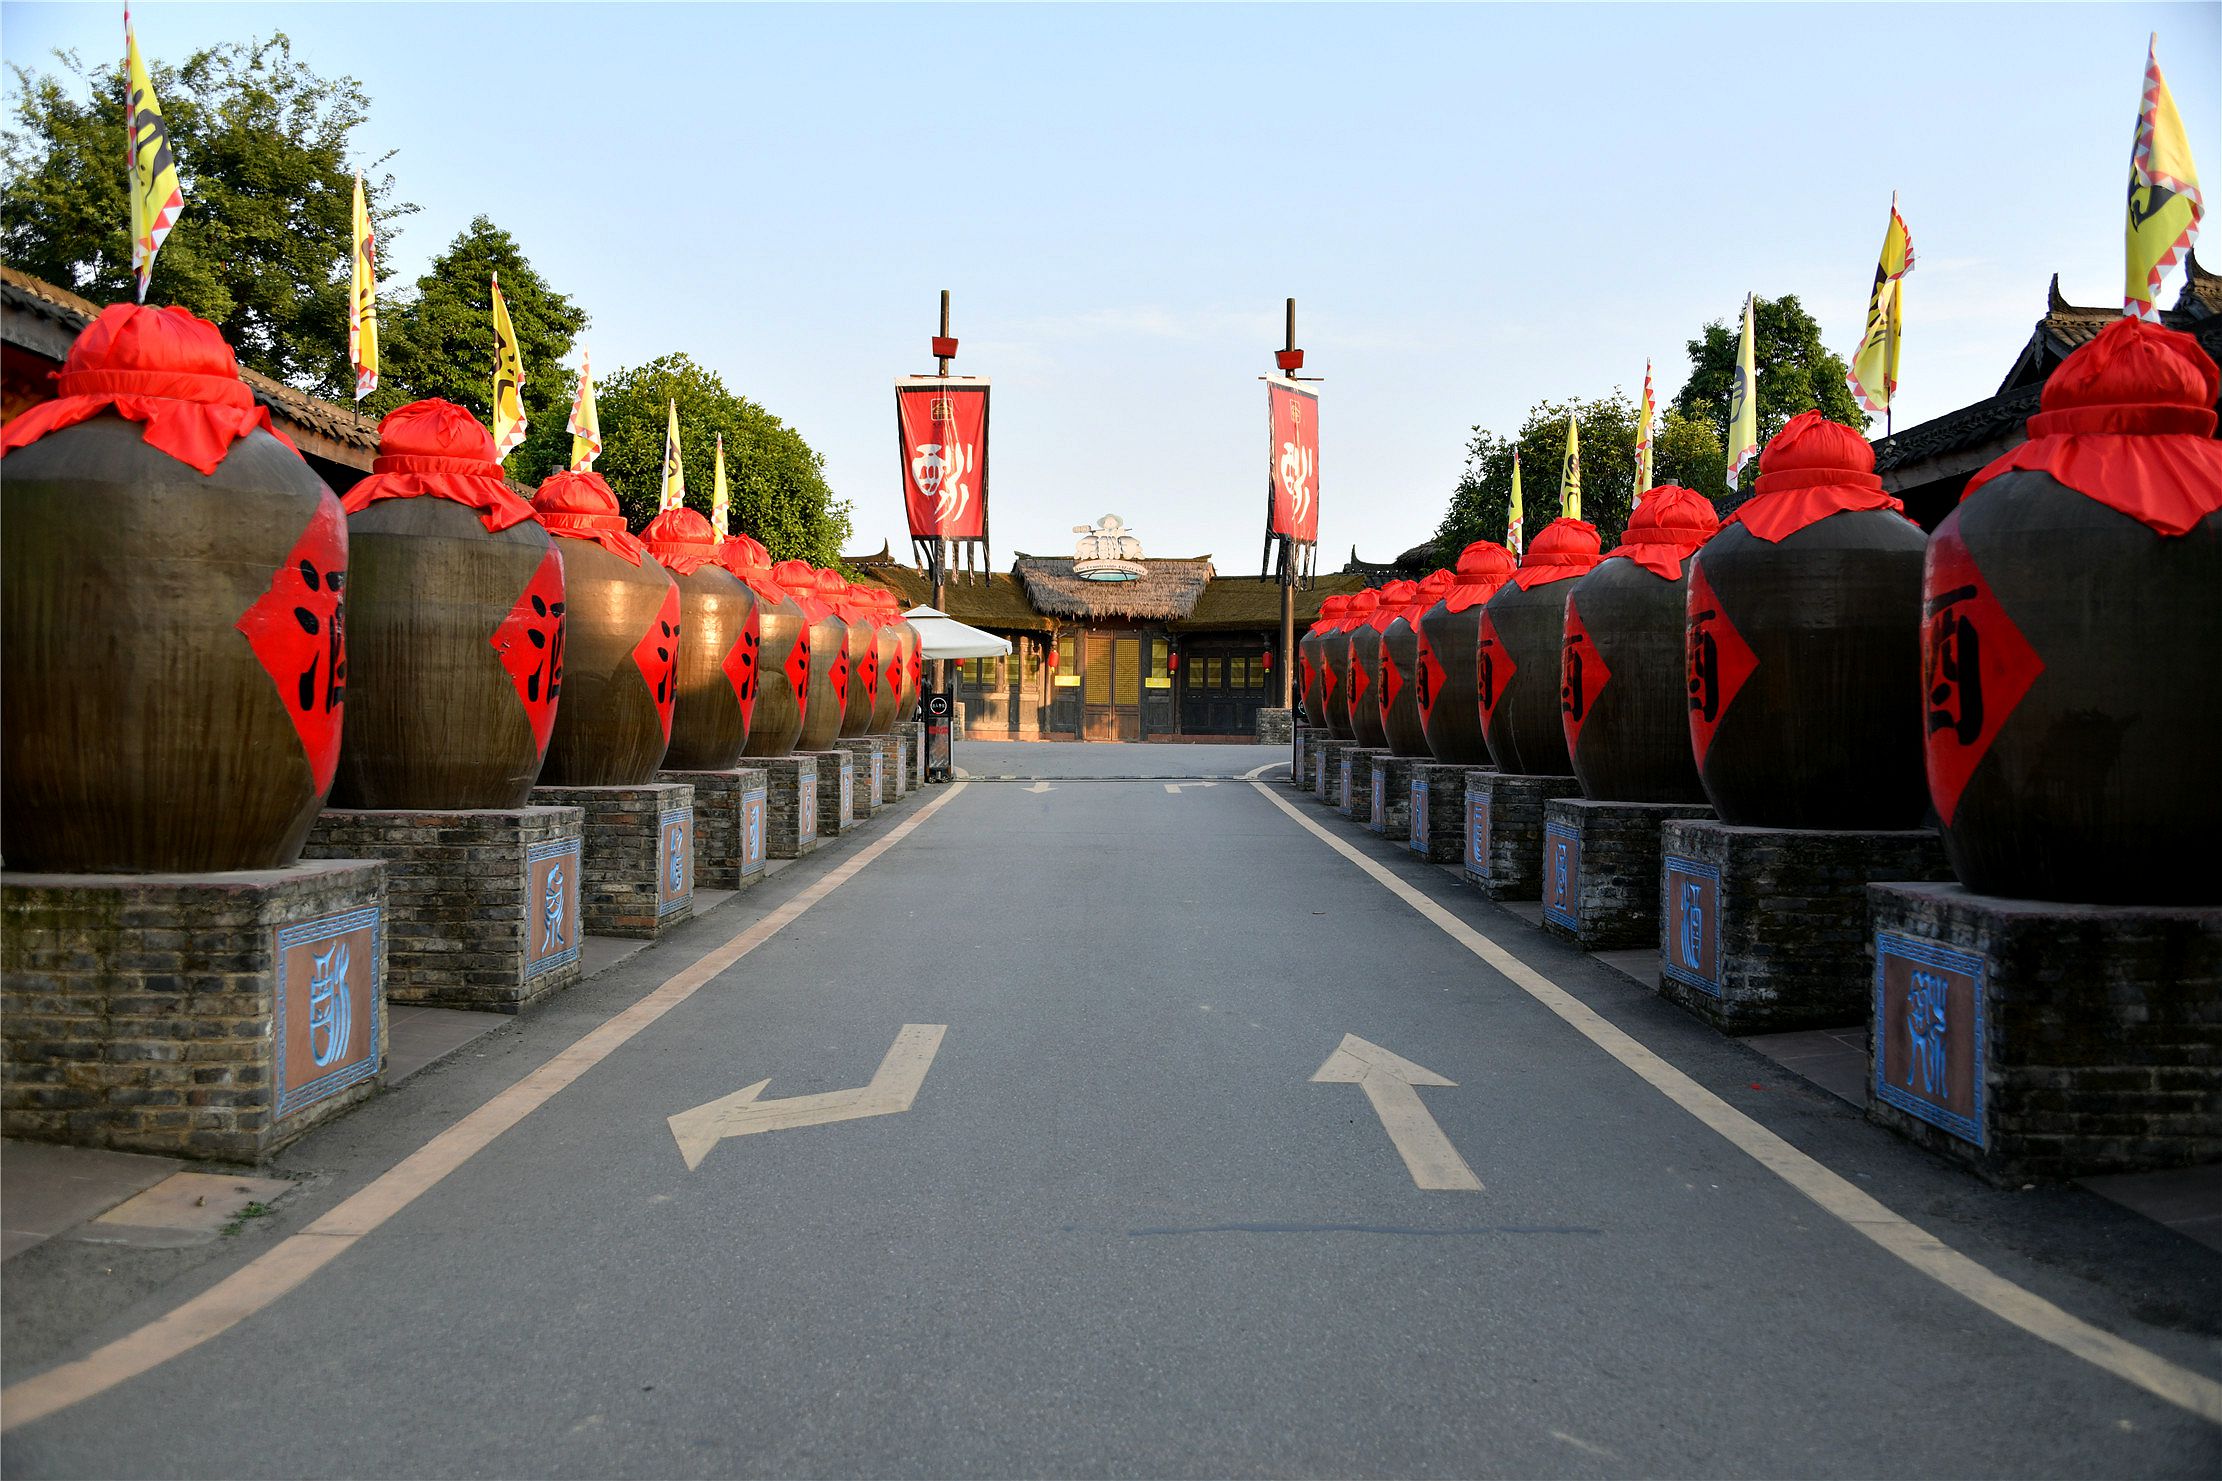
1558, 484, 1720, 802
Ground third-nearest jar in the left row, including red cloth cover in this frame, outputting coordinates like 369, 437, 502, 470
533, 471, 680, 786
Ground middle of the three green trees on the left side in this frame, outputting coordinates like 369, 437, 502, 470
364, 215, 587, 464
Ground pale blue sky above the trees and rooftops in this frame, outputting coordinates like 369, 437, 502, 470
0, 0, 2222, 573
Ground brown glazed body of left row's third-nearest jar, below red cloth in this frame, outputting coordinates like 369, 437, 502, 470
540, 535, 678, 786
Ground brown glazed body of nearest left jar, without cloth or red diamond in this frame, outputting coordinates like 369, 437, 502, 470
0, 413, 337, 873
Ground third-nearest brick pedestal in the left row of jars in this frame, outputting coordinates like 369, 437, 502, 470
533, 782, 693, 939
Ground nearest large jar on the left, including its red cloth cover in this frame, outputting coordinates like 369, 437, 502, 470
0, 304, 351, 873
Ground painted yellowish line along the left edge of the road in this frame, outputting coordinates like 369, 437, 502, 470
0, 782, 964, 1430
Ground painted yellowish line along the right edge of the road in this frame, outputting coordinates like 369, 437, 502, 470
1251, 782, 2222, 1423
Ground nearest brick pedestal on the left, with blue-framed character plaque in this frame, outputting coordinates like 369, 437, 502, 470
0, 859, 387, 1161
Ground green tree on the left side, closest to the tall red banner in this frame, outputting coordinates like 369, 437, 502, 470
586, 355, 849, 566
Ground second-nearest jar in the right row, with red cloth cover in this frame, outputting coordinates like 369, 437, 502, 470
1684, 411, 1929, 828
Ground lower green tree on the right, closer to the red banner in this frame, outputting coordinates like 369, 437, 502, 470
1435, 389, 1635, 560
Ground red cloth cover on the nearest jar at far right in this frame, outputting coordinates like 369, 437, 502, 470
1960, 318, 2222, 535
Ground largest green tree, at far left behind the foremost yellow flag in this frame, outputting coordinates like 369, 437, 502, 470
0, 33, 416, 400
